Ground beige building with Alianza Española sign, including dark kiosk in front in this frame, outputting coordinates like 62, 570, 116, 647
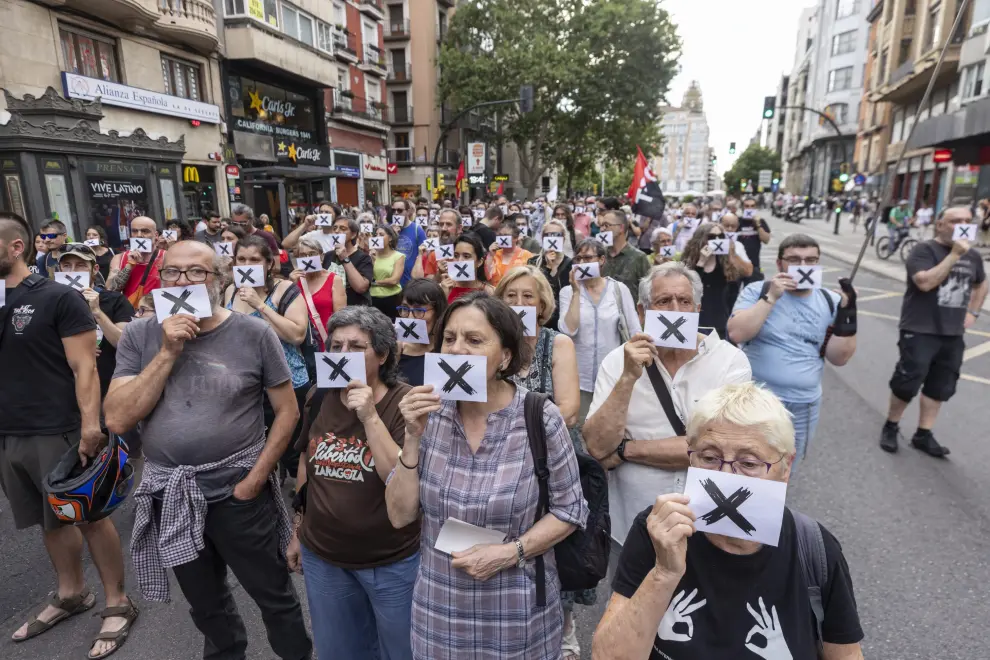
0, 0, 228, 242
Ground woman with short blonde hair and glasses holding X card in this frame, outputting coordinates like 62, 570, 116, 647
592, 383, 863, 660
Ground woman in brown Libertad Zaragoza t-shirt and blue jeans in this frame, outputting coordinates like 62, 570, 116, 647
287, 306, 419, 660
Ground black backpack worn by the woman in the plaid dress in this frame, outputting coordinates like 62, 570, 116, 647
525, 392, 612, 607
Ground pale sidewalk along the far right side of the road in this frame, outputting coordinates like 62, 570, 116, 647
761, 212, 990, 312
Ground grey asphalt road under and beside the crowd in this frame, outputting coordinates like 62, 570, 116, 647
0, 222, 990, 660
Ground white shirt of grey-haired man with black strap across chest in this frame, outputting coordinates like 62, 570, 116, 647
579, 331, 753, 544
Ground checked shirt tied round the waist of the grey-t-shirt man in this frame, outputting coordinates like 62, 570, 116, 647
131, 442, 292, 603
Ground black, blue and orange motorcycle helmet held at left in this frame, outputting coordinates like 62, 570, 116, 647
44, 433, 134, 523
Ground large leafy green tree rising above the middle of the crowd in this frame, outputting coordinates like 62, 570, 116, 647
439, 0, 680, 195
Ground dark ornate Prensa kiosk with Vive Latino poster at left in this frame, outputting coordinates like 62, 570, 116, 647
0, 87, 188, 248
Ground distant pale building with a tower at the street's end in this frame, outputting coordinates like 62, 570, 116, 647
653, 81, 711, 195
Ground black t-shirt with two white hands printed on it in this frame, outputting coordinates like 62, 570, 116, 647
612, 507, 863, 660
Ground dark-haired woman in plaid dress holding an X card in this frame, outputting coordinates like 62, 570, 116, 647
385, 293, 588, 660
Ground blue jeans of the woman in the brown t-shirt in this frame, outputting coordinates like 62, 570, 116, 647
302, 545, 419, 660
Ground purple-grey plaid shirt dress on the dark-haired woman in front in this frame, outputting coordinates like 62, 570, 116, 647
412, 387, 588, 660
